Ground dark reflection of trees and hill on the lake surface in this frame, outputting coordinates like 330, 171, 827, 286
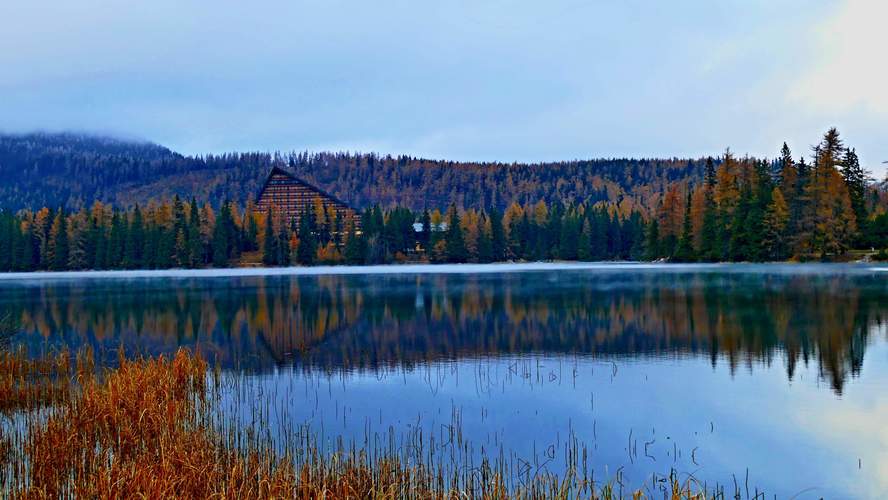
0, 267, 888, 394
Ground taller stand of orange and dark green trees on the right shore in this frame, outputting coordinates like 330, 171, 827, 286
646, 128, 888, 262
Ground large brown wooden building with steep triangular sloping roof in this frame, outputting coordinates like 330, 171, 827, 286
257, 167, 360, 228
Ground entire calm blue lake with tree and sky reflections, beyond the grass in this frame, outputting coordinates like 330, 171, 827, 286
0, 264, 888, 498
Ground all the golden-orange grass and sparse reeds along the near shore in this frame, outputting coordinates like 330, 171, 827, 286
0, 350, 723, 500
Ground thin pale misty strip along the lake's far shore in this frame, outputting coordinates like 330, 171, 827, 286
0, 261, 888, 282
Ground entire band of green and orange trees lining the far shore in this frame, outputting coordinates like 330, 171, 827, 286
0, 129, 888, 271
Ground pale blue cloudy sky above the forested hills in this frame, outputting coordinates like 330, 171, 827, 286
0, 0, 888, 178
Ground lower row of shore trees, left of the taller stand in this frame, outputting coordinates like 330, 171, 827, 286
0, 197, 646, 271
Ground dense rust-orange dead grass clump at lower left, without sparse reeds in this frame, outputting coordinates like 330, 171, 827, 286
27, 351, 302, 498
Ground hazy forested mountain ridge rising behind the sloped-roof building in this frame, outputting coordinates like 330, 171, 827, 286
0, 133, 704, 213
